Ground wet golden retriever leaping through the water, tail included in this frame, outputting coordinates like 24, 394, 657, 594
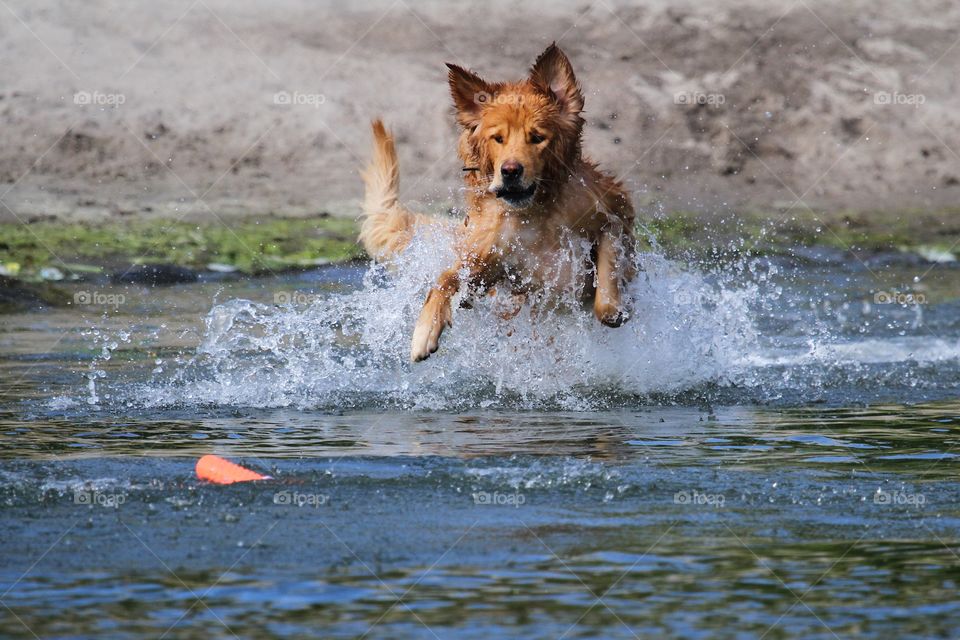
360, 44, 634, 362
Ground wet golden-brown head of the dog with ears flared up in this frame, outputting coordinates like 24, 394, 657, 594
447, 44, 583, 208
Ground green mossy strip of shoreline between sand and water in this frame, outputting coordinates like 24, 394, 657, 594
0, 208, 960, 313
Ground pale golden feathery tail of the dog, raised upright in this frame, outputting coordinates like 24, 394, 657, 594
360, 120, 434, 261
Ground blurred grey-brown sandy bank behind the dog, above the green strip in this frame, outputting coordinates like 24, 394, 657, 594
0, 0, 960, 225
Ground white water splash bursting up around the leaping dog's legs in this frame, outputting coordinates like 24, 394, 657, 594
138, 230, 757, 409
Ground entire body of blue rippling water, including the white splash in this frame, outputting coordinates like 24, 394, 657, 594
0, 242, 960, 638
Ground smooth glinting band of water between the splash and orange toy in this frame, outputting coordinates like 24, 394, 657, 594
0, 402, 960, 473
